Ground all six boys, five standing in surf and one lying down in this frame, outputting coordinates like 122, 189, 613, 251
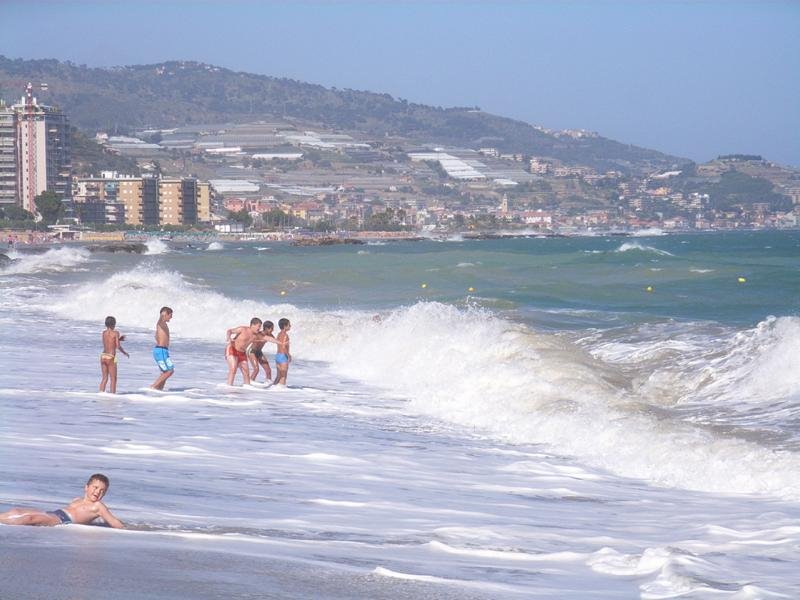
0, 306, 292, 529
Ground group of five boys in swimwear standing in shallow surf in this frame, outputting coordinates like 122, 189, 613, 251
100, 306, 292, 394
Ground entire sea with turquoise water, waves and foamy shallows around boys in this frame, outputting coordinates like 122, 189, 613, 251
0, 231, 800, 600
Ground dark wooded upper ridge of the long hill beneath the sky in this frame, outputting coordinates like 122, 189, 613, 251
0, 56, 686, 174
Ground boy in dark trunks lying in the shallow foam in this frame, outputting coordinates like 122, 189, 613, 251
0, 473, 125, 529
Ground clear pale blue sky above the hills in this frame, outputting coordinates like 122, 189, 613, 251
0, 0, 800, 167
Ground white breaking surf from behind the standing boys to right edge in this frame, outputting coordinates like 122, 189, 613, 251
41, 267, 800, 499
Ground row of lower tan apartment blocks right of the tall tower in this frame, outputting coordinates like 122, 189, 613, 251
73, 171, 211, 226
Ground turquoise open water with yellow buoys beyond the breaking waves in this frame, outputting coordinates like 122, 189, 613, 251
173, 232, 800, 326
